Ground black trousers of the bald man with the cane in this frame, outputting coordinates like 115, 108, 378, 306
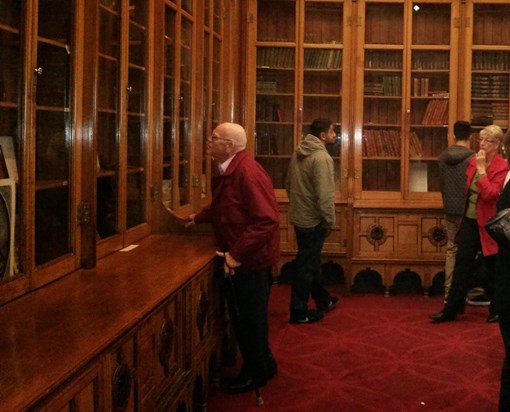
224, 268, 276, 386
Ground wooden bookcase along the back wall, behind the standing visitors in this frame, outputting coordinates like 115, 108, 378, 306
246, 0, 510, 291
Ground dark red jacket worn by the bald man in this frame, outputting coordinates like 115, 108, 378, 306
195, 150, 280, 268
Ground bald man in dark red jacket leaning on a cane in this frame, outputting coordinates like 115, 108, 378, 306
188, 123, 280, 393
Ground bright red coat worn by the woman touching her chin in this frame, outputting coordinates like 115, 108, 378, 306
466, 154, 508, 256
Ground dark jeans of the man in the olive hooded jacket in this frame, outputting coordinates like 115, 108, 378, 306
290, 225, 331, 314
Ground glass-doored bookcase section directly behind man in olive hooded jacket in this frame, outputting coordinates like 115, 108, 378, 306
248, 0, 350, 195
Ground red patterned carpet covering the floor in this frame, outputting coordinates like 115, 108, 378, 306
208, 285, 503, 412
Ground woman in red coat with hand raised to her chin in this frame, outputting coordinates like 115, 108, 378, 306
431, 125, 508, 323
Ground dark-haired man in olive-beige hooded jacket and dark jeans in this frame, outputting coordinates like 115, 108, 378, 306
286, 119, 339, 324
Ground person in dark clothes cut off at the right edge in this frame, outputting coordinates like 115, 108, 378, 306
494, 130, 510, 412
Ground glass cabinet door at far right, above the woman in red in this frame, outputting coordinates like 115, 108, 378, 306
468, 2, 510, 140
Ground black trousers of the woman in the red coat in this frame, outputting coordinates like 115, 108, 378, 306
445, 218, 496, 314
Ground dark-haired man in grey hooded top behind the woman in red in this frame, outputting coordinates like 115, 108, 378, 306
437, 120, 475, 299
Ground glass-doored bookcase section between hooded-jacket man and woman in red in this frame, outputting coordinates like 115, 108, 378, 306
356, 1, 459, 201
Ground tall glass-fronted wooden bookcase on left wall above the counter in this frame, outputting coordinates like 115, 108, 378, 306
0, 0, 229, 304
